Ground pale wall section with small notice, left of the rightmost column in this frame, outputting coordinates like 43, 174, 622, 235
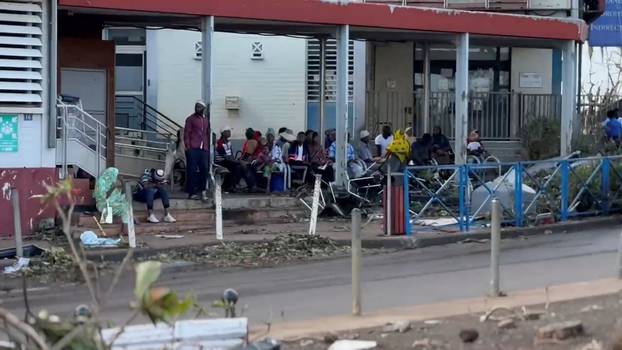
512, 48, 553, 94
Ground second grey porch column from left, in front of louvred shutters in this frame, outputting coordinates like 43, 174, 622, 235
335, 25, 350, 184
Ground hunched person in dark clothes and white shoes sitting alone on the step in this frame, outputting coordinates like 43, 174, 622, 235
134, 169, 176, 224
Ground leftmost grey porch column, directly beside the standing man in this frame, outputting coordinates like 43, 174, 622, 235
201, 16, 214, 189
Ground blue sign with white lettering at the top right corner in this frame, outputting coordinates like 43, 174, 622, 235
589, 0, 622, 47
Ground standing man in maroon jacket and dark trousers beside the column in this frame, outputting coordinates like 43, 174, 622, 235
184, 101, 211, 200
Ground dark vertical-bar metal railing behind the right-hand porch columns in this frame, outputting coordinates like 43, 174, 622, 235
366, 91, 572, 141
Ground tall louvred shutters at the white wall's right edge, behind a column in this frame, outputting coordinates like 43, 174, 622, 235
307, 39, 354, 102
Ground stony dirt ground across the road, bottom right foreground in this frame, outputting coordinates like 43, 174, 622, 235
283, 294, 622, 350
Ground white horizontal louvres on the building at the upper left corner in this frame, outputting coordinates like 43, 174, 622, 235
0, 0, 44, 110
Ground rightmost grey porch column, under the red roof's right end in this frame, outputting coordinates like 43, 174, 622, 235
560, 41, 577, 156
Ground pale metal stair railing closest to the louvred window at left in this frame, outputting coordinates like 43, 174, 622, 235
56, 102, 108, 177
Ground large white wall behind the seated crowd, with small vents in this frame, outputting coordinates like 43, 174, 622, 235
152, 30, 306, 138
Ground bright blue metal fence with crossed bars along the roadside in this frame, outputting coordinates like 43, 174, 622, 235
404, 156, 622, 233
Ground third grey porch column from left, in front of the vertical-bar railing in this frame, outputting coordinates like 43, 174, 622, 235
454, 33, 469, 164
